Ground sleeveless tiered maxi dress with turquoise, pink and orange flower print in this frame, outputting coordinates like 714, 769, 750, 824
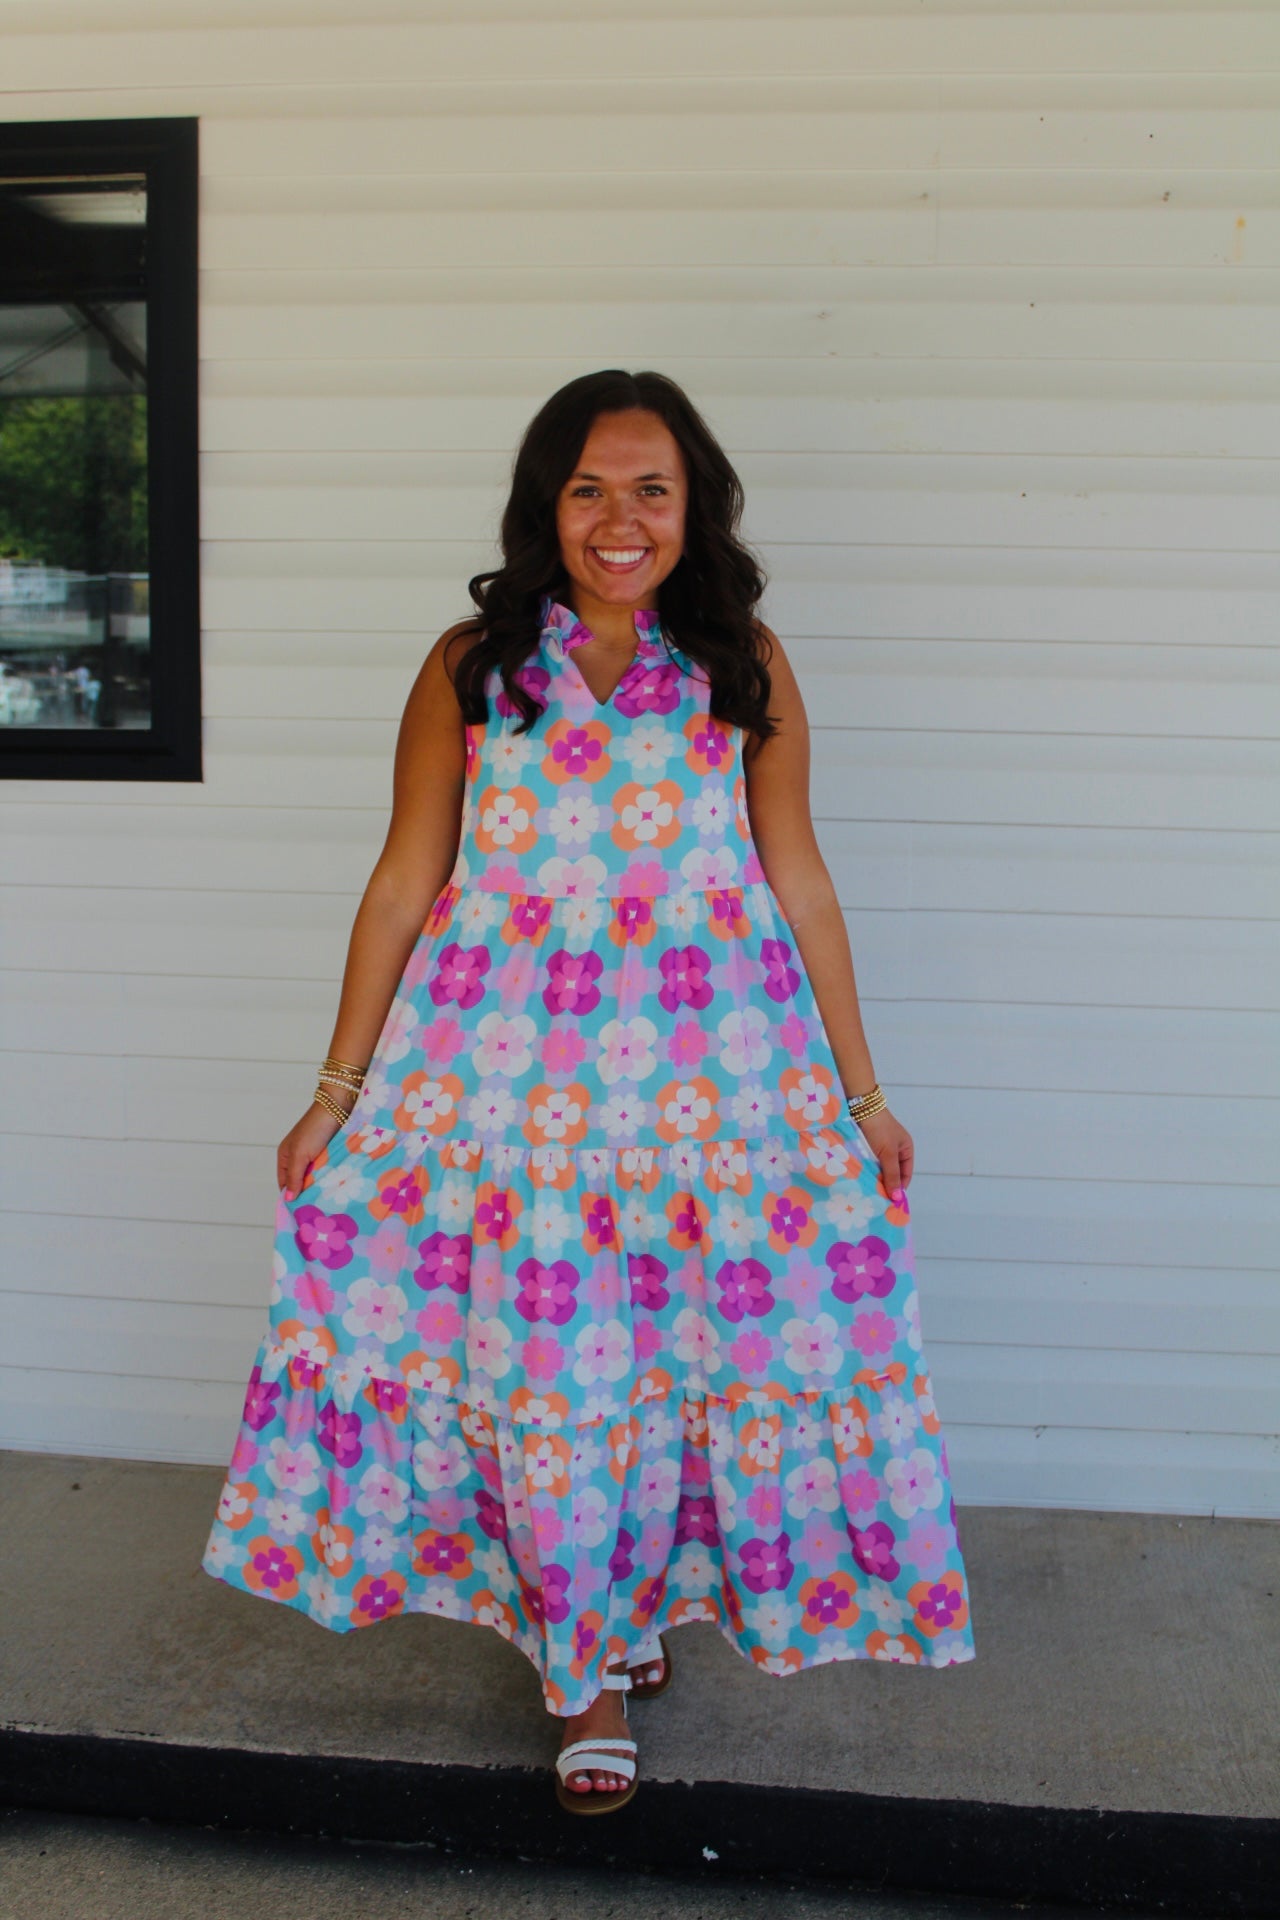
203, 599, 973, 1715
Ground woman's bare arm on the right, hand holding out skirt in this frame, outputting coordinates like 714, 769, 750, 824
743, 628, 915, 1194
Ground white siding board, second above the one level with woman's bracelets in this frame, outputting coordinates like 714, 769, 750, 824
6, 887, 1280, 1012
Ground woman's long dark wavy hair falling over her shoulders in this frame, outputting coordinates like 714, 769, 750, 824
445, 367, 777, 739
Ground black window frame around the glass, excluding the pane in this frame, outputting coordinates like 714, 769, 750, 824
0, 117, 203, 781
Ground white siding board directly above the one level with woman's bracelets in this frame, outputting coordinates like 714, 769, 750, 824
0, 975, 1280, 1098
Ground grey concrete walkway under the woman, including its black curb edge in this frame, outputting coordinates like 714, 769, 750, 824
0, 1453, 1280, 1916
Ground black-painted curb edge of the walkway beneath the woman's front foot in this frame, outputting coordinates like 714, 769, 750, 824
0, 1728, 1280, 1920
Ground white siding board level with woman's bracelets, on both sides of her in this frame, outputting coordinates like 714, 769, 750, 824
0, 1052, 1280, 1188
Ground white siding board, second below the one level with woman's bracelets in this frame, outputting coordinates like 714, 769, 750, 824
0, 1213, 1280, 1365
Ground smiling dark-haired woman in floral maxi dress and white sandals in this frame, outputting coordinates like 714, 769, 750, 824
205, 371, 973, 1812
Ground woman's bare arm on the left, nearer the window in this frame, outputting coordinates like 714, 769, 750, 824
276, 622, 475, 1194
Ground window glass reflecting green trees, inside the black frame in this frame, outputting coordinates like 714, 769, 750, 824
0, 173, 152, 732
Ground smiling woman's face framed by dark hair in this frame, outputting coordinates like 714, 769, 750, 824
557, 407, 689, 626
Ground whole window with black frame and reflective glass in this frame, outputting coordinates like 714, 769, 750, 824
0, 119, 200, 780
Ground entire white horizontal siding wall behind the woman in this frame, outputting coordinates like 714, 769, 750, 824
0, 11, 1280, 1515
